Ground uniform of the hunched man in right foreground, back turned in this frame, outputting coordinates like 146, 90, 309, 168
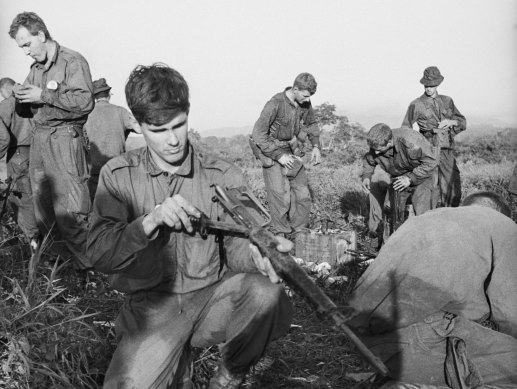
349, 205, 517, 385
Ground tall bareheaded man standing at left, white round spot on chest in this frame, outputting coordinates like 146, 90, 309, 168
9, 12, 94, 270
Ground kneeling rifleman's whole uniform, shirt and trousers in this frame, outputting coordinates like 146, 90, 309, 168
88, 148, 292, 388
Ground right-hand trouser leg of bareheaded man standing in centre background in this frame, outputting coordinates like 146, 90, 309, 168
289, 166, 311, 231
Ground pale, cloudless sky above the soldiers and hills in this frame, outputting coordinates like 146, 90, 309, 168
0, 0, 517, 135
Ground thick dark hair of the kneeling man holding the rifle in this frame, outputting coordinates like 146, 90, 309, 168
126, 63, 190, 126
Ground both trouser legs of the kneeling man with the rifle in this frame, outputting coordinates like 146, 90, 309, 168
104, 273, 292, 389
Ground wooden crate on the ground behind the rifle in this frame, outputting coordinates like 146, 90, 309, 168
295, 230, 357, 266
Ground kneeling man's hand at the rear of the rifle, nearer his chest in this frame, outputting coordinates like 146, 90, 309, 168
142, 195, 201, 237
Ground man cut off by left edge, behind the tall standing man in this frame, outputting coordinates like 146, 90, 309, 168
0, 77, 39, 250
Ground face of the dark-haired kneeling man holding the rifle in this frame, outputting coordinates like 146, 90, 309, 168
140, 112, 188, 170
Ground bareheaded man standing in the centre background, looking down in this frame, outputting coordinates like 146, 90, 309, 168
250, 73, 321, 235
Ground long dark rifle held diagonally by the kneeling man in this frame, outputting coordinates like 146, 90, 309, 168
192, 185, 389, 376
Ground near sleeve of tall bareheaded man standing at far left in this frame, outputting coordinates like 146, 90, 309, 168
41, 57, 94, 119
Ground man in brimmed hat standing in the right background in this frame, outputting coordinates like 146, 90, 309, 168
402, 66, 467, 207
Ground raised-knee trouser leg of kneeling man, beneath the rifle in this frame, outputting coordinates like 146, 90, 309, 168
192, 273, 292, 374
